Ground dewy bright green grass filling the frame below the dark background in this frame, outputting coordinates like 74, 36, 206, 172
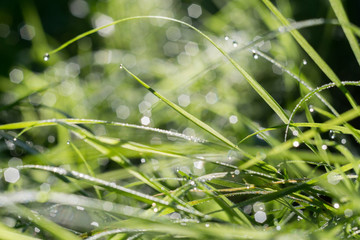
0, 0, 360, 240
